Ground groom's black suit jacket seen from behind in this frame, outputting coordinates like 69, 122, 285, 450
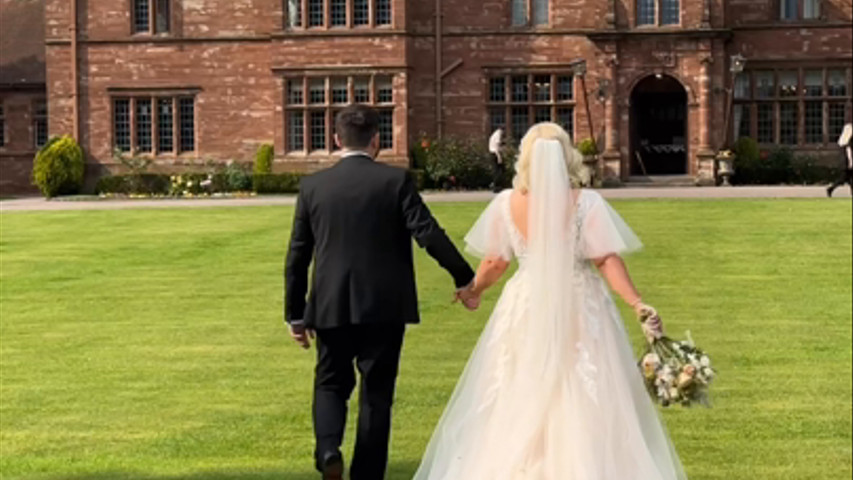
285, 155, 474, 329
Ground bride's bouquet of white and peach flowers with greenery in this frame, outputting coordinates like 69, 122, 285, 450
640, 311, 716, 407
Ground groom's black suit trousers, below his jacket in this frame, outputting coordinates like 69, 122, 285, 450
314, 324, 405, 480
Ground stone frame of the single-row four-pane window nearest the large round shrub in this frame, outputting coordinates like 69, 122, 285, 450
109, 88, 200, 158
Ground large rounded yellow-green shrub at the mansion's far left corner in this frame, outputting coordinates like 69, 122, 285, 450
33, 135, 86, 198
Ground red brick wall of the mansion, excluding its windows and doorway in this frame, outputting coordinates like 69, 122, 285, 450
33, 0, 851, 189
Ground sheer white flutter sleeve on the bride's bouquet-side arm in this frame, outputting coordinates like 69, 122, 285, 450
581, 191, 643, 258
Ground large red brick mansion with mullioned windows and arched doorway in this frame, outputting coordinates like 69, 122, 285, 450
4, 0, 853, 193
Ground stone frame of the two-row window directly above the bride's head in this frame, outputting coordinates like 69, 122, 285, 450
483, 68, 579, 142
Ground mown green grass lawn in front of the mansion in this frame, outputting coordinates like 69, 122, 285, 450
0, 200, 853, 480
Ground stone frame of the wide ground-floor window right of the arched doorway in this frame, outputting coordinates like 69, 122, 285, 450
731, 63, 853, 148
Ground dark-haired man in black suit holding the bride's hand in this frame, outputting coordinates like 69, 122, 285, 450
284, 105, 479, 480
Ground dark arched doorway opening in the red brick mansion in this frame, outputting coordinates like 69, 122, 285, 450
631, 74, 687, 175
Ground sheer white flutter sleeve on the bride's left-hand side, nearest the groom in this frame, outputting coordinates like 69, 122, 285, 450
465, 191, 513, 261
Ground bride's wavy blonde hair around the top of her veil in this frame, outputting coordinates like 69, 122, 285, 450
512, 123, 590, 193
